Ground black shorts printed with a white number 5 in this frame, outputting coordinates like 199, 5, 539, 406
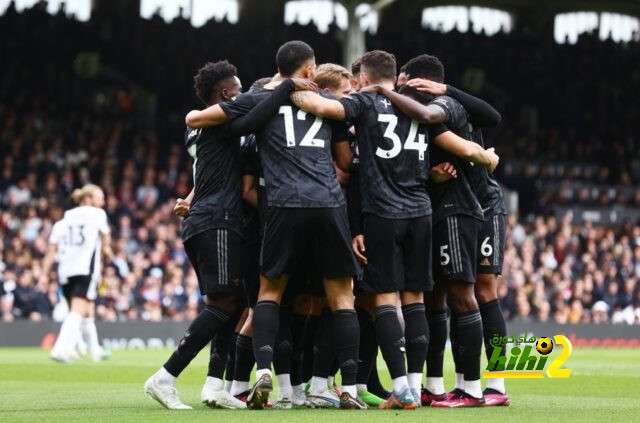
433, 214, 482, 283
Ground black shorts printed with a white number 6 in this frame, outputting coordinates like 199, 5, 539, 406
476, 214, 507, 275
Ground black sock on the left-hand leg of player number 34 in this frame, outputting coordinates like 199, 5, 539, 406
376, 305, 407, 379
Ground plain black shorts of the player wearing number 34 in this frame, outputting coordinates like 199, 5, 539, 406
358, 214, 433, 293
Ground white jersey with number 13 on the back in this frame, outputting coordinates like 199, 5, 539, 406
49, 206, 110, 284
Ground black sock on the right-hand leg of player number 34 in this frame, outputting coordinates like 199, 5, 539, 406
402, 303, 429, 373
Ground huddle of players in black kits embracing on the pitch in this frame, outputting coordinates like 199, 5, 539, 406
43, 41, 509, 409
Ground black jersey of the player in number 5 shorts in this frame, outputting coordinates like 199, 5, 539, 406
429, 96, 484, 223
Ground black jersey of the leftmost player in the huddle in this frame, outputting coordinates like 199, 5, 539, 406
182, 124, 248, 241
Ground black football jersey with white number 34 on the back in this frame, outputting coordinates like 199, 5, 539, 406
340, 92, 431, 219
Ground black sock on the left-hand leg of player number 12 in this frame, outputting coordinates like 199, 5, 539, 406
252, 301, 280, 370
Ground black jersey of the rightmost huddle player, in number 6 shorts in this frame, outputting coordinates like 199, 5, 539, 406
469, 124, 507, 218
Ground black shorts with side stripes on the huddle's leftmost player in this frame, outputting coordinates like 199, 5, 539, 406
184, 229, 242, 295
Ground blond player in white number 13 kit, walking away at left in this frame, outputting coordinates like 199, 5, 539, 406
40, 184, 113, 363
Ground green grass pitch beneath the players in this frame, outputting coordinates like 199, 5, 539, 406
0, 348, 640, 423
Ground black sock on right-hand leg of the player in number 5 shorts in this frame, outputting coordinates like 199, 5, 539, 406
456, 309, 482, 380
